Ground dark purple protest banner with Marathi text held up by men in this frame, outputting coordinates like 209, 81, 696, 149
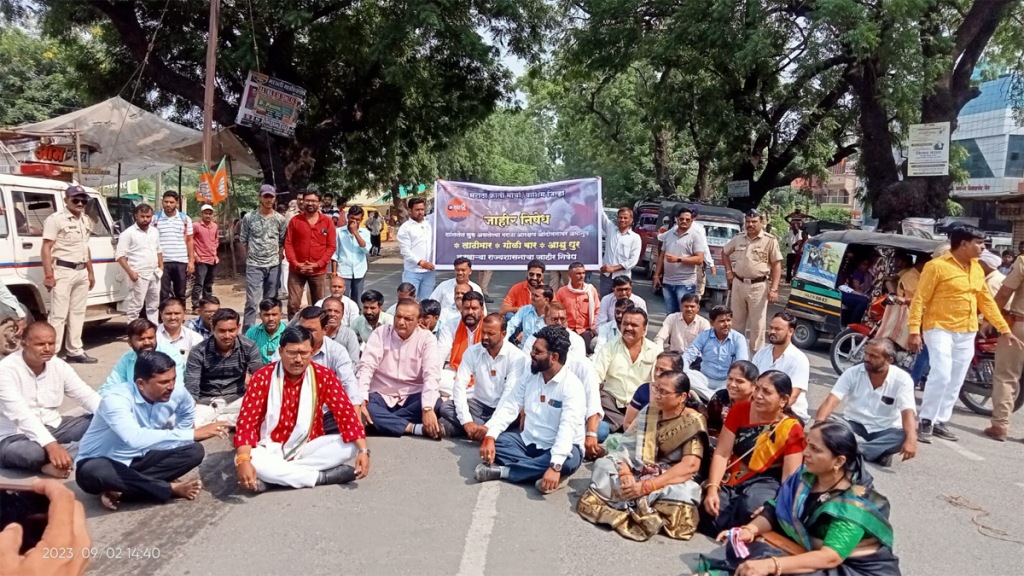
433, 178, 602, 271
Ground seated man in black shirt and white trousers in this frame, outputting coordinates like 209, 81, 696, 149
185, 308, 263, 426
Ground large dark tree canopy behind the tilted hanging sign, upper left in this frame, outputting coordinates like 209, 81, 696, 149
14, 0, 549, 191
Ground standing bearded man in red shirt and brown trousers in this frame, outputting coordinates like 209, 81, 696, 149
285, 191, 338, 316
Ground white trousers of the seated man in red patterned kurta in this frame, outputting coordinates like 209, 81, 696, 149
252, 434, 357, 488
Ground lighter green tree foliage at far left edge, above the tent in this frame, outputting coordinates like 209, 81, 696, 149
0, 27, 90, 126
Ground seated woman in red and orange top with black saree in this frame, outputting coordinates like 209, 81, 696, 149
700, 370, 806, 537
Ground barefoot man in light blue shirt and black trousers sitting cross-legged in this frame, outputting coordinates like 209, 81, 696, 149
75, 348, 227, 510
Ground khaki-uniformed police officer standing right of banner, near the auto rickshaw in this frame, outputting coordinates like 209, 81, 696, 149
722, 210, 782, 357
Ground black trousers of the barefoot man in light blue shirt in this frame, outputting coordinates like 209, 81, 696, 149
75, 442, 206, 502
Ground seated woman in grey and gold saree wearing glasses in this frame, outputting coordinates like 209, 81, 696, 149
577, 371, 708, 541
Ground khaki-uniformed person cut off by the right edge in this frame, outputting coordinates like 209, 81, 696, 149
985, 256, 1024, 442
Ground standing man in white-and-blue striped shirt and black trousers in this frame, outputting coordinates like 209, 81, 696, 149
153, 191, 196, 301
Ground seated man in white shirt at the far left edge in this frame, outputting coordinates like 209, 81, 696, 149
0, 322, 99, 478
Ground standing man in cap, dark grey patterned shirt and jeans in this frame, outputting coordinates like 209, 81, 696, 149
239, 184, 288, 328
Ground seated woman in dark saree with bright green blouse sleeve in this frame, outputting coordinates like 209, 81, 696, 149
697, 420, 900, 576
